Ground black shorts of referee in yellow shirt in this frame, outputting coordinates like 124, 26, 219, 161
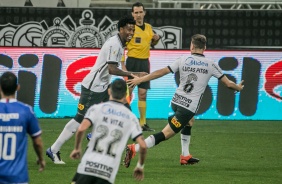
125, 57, 150, 89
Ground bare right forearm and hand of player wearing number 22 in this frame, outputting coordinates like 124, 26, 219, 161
133, 136, 147, 181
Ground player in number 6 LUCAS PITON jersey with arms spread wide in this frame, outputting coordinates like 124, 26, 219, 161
124, 34, 244, 167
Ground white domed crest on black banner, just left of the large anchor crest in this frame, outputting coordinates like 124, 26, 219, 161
41, 17, 70, 47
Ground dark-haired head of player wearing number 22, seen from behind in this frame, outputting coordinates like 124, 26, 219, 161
110, 79, 127, 100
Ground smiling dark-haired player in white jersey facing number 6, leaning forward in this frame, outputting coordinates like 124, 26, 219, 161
46, 17, 146, 164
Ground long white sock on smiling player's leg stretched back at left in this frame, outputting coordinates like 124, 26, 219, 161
51, 119, 80, 153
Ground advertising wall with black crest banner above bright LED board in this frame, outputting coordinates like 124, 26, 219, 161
0, 7, 282, 120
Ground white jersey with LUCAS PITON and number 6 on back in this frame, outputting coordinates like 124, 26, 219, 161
168, 54, 224, 113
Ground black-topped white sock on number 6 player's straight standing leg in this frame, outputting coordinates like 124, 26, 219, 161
180, 126, 192, 156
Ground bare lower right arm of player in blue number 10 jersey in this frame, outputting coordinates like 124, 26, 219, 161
32, 136, 46, 172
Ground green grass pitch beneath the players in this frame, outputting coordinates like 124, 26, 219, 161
28, 119, 282, 184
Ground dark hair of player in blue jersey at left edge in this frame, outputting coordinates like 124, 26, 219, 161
0, 72, 18, 96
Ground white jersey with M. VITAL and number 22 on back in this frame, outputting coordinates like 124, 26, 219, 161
77, 101, 142, 183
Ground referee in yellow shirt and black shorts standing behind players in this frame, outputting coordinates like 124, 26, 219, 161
122, 2, 160, 131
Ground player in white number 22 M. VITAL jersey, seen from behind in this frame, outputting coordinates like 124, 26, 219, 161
70, 79, 146, 184
